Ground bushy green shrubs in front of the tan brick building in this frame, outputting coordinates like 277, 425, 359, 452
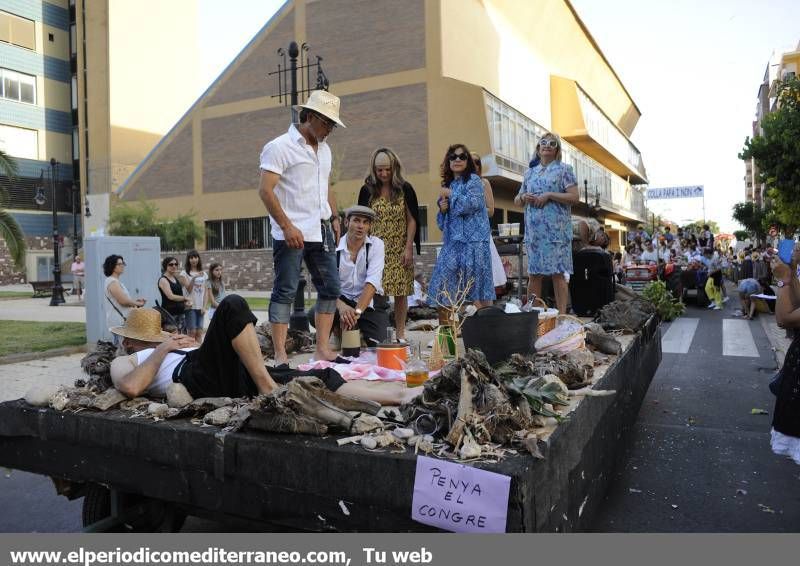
108, 200, 203, 250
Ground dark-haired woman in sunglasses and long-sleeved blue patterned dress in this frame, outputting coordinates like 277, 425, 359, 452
428, 144, 495, 307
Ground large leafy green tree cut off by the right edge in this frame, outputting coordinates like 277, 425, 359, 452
739, 78, 800, 234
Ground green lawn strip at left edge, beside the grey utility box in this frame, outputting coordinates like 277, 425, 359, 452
0, 320, 86, 356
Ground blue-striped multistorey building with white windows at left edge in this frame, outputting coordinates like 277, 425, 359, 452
0, 0, 82, 283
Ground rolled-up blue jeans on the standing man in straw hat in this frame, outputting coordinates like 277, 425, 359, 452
269, 222, 340, 324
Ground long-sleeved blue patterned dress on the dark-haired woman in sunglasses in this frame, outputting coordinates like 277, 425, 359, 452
428, 174, 495, 306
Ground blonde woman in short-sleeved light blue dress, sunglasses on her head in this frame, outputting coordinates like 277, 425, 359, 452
514, 134, 579, 314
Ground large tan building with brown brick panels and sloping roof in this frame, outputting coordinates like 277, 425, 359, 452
116, 0, 647, 258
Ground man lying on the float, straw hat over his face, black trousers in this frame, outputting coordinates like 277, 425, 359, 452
111, 295, 422, 405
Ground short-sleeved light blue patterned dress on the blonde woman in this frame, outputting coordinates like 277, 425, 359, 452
519, 161, 577, 275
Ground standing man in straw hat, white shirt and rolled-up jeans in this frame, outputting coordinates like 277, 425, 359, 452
259, 90, 344, 365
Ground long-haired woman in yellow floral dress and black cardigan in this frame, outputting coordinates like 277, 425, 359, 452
358, 147, 420, 340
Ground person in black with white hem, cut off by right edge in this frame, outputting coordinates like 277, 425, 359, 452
771, 255, 800, 464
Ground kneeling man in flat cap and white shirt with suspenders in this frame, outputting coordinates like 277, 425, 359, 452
309, 205, 389, 346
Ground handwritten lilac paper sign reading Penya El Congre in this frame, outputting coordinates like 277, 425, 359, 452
411, 456, 511, 533
